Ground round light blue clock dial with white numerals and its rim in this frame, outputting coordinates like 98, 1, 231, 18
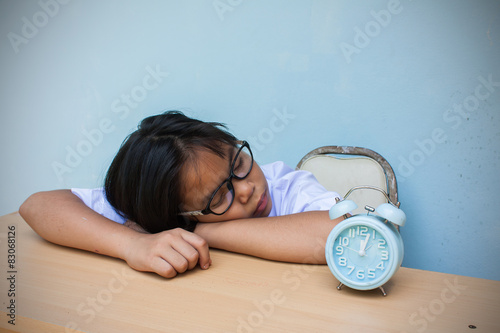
326, 215, 402, 290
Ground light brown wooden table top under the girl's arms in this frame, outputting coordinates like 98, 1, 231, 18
0, 213, 500, 333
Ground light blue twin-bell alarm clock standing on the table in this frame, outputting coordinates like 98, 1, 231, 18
325, 186, 406, 296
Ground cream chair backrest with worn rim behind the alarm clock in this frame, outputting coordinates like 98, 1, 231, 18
296, 146, 399, 214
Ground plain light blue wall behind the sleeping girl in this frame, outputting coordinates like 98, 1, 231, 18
0, 0, 500, 280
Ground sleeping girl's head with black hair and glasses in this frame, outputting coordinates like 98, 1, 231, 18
105, 111, 271, 233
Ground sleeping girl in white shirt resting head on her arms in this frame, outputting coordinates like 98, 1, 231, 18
19, 111, 342, 278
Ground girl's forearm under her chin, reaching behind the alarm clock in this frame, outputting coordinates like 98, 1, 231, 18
195, 211, 344, 264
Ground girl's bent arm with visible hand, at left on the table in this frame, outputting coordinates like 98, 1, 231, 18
19, 190, 210, 277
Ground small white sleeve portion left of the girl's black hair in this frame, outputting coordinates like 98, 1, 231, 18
71, 187, 127, 224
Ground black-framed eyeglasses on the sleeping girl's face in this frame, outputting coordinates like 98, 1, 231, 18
179, 141, 253, 216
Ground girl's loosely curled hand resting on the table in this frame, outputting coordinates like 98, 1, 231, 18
123, 226, 212, 278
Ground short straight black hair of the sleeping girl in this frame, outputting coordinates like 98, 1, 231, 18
104, 111, 236, 233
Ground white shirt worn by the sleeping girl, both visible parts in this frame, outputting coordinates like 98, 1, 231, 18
71, 162, 340, 224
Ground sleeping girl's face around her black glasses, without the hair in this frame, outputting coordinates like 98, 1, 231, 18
182, 146, 272, 222
